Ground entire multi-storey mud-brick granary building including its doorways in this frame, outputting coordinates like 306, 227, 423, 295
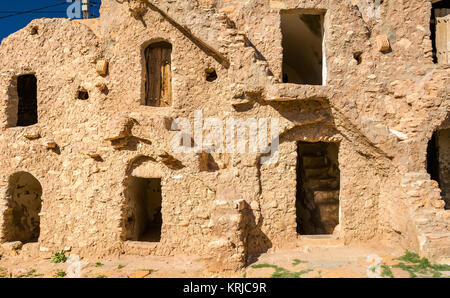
0, 0, 450, 271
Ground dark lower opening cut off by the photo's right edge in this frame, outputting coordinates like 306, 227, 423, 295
427, 129, 450, 210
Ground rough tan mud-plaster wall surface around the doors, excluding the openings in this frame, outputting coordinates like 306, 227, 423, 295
0, 0, 450, 271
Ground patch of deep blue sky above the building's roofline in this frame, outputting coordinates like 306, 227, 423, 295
0, 0, 101, 40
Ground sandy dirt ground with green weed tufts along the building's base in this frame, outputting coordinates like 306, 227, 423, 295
0, 245, 450, 278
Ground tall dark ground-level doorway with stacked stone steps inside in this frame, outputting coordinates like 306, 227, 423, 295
296, 142, 340, 235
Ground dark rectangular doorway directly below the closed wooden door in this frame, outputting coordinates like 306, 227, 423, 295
127, 176, 162, 242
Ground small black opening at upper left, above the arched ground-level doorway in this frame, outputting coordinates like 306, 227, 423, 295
17, 74, 38, 126
